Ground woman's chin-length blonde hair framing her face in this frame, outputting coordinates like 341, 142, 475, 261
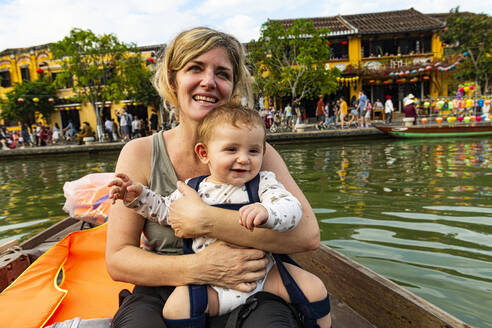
153, 27, 253, 117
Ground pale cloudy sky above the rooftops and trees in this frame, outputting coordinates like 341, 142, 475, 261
0, 0, 492, 51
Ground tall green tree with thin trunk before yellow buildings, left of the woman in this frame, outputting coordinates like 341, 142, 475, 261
52, 28, 139, 138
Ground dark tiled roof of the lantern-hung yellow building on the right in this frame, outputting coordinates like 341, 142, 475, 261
272, 8, 444, 35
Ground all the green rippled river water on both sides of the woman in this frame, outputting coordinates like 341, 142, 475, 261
0, 138, 492, 327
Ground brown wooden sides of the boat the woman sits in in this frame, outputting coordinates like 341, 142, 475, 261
0, 218, 471, 328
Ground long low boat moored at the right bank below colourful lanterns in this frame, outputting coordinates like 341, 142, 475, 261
373, 118, 492, 138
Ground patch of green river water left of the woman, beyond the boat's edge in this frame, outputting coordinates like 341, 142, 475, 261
0, 153, 118, 244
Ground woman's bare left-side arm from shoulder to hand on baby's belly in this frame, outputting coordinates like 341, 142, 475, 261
106, 137, 267, 291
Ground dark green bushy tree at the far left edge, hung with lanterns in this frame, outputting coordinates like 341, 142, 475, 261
1, 75, 56, 125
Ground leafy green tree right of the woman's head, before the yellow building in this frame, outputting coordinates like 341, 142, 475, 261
249, 19, 339, 99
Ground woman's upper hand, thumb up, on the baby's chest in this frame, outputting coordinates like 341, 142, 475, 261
168, 181, 211, 238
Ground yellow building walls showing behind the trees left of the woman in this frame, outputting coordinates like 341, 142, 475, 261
0, 44, 163, 130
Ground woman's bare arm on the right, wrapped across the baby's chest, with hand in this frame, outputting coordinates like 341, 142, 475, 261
169, 144, 320, 253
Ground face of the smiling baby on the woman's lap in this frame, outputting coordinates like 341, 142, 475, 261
207, 124, 265, 185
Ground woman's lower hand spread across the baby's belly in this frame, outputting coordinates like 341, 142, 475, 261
196, 240, 268, 292
